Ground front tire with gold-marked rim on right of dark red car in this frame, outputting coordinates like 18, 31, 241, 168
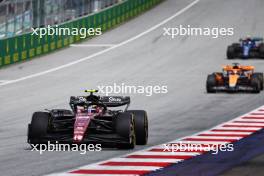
116, 112, 136, 149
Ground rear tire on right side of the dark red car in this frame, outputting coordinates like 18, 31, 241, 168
127, 110, 148, 145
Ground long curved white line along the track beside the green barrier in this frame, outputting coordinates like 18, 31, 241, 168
0, 0, 200, 86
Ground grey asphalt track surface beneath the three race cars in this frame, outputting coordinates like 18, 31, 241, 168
0, 0, 264, 176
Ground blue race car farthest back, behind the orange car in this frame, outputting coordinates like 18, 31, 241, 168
227, 37, 264, 59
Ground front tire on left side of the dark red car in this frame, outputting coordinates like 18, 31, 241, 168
28, 112, 50, 144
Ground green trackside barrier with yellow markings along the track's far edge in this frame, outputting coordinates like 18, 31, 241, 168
0, 0, 162, 68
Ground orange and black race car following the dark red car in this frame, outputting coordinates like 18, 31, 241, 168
206, 63, 263, 93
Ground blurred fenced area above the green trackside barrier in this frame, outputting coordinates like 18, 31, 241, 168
0, 0, 124, 39
